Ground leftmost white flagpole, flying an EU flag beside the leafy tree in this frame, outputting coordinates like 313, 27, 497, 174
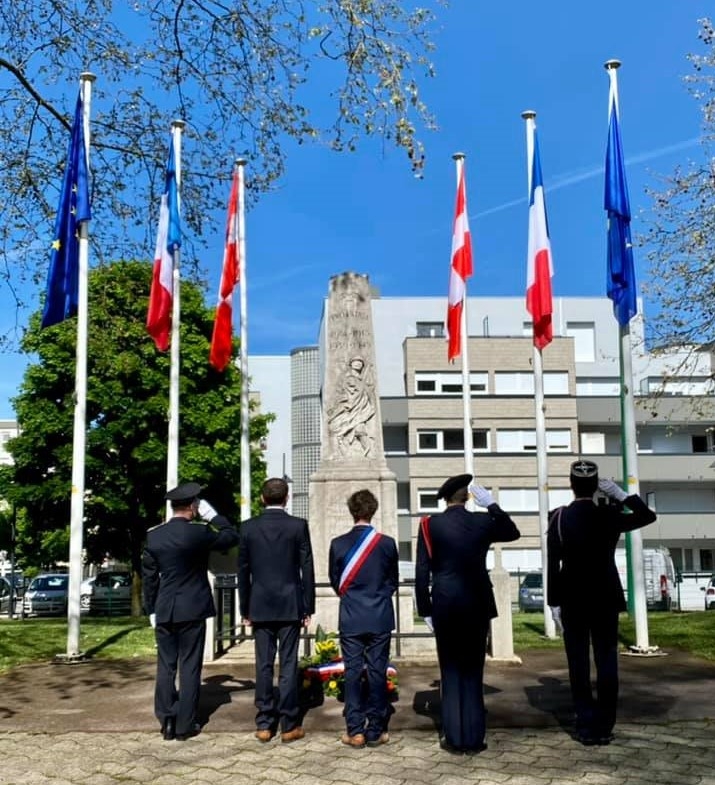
66, 71, 96, 660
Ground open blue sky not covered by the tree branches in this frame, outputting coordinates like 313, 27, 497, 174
0, 0, 712, 417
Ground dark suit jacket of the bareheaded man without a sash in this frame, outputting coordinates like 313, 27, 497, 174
238, 507, 315, 623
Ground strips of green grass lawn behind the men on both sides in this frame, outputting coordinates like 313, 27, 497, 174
0, 611, 715, 673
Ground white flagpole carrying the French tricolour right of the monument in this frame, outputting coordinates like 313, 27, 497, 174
521, 109, 556, 638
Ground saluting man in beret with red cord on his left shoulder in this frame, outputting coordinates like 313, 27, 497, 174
415, 474, 520, 754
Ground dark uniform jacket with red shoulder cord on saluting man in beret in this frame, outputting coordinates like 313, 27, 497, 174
415, 504, 521, 623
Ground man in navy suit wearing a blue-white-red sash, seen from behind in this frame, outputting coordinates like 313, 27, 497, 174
328, 490, 399, 747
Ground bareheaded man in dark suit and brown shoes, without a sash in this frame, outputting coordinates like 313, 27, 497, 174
238, 477, 315, 742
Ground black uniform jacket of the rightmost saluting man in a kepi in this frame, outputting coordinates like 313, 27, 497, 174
546, 495, 656, 612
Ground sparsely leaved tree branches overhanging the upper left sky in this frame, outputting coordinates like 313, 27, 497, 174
0, 0, 442, 330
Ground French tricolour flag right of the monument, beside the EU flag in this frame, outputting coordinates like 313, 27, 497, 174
526, 117, 554, 349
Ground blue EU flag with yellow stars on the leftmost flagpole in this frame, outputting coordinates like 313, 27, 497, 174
42, 90, 91, 327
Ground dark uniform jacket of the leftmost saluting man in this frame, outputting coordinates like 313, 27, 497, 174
142, 515, 238, 624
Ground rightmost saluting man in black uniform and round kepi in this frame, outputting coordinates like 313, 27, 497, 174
546, 461, 656, 744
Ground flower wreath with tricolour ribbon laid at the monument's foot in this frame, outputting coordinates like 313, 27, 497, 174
298, 626, 399, 705
